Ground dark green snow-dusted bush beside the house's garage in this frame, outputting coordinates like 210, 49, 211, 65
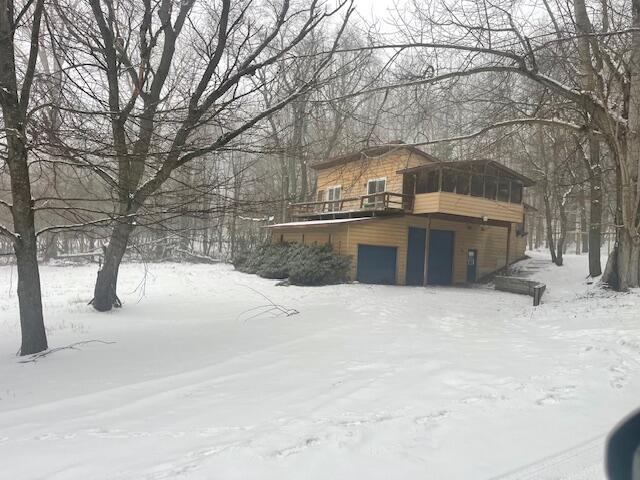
233, 243, 351, 285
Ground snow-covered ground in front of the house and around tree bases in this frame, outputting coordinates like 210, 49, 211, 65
0, 254, 640, 480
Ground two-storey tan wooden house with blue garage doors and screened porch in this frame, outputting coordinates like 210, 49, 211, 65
269, 142, 534, 285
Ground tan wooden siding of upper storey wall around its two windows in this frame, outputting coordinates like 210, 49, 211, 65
316, 149, 428, 198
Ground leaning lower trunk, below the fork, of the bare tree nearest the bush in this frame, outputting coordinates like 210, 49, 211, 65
91, 222, 134, 312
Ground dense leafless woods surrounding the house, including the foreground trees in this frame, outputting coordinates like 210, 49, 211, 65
0, 0, 640, 355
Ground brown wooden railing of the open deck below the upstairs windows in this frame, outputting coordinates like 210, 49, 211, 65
290, 192, 413, 217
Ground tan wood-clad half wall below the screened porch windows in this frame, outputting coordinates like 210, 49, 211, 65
413, 192, 524, 223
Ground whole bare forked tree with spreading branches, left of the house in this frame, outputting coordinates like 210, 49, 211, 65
52, 0, 352, 311
